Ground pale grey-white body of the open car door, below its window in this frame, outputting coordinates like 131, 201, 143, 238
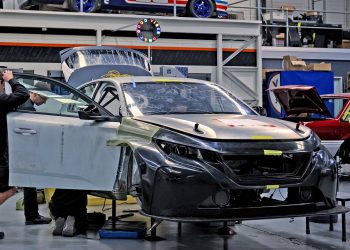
8, 112, 120, 191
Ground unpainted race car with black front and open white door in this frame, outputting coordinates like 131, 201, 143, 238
7, 46, 338, 221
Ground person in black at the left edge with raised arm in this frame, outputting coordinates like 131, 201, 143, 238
0, 70, 29, 239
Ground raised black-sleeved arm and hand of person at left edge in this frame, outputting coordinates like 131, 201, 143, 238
0, 71, 29, 109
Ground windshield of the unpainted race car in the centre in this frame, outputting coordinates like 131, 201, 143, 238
122, 81, 256, 116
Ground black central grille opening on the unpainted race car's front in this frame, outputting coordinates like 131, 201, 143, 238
216, 152, 311, 185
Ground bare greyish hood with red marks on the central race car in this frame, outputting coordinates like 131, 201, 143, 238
133, 114, 311, 140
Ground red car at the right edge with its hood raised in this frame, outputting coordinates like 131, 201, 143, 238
269, 85, 350, 164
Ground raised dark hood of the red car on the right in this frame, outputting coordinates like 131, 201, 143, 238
268, 85, 331, 116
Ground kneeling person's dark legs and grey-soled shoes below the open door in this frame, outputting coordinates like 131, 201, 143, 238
49, 189, 87, 236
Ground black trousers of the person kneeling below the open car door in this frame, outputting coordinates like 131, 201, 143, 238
49, 189, 87, 231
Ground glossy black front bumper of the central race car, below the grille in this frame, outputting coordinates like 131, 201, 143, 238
138, 144, 337, 220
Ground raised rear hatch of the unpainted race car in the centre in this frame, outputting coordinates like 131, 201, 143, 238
60, 46, 153, 87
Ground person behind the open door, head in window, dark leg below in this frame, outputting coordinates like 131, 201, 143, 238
18, 92, 52, 225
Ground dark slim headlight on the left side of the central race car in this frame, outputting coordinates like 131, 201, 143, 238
156, 140, 220, 163
